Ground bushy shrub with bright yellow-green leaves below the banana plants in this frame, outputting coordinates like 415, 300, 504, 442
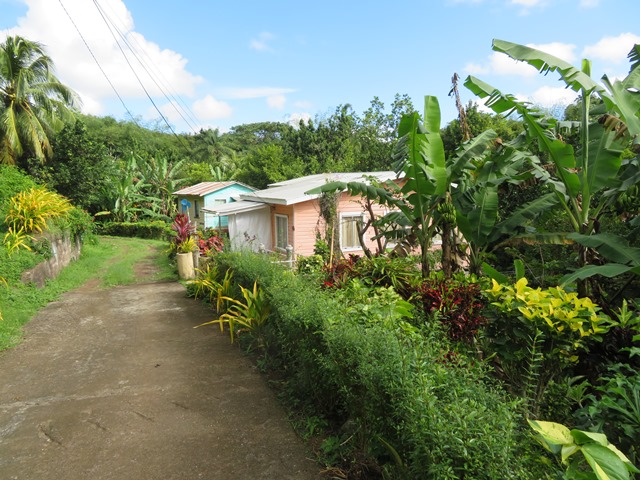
483, 278, 610, 417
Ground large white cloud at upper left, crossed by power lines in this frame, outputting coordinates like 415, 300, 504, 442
0, 0, 202, 113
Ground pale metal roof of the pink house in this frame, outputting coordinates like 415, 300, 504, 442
240, 171, 396, 205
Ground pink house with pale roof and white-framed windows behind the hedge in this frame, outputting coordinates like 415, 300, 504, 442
203, 171, 396, 256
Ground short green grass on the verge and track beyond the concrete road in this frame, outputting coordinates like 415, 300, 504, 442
0, 237, 176, 351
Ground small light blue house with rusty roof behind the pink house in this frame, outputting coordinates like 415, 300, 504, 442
173, 181, 256, 228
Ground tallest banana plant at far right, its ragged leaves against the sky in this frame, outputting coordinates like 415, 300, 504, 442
465, 40, 640, 296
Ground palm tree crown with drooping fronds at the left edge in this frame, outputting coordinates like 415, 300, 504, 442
0, 36, 79, 164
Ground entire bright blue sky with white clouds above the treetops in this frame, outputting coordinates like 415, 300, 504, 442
0, 0, 640, 132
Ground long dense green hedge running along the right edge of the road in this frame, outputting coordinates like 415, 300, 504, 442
206, 252, 543, 480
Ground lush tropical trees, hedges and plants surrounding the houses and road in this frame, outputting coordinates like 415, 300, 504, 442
0, 31, 640, 480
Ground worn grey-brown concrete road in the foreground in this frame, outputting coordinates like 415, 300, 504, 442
0, 283, 321, 480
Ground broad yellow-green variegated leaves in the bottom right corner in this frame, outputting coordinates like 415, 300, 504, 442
527, 420, 640, 480
